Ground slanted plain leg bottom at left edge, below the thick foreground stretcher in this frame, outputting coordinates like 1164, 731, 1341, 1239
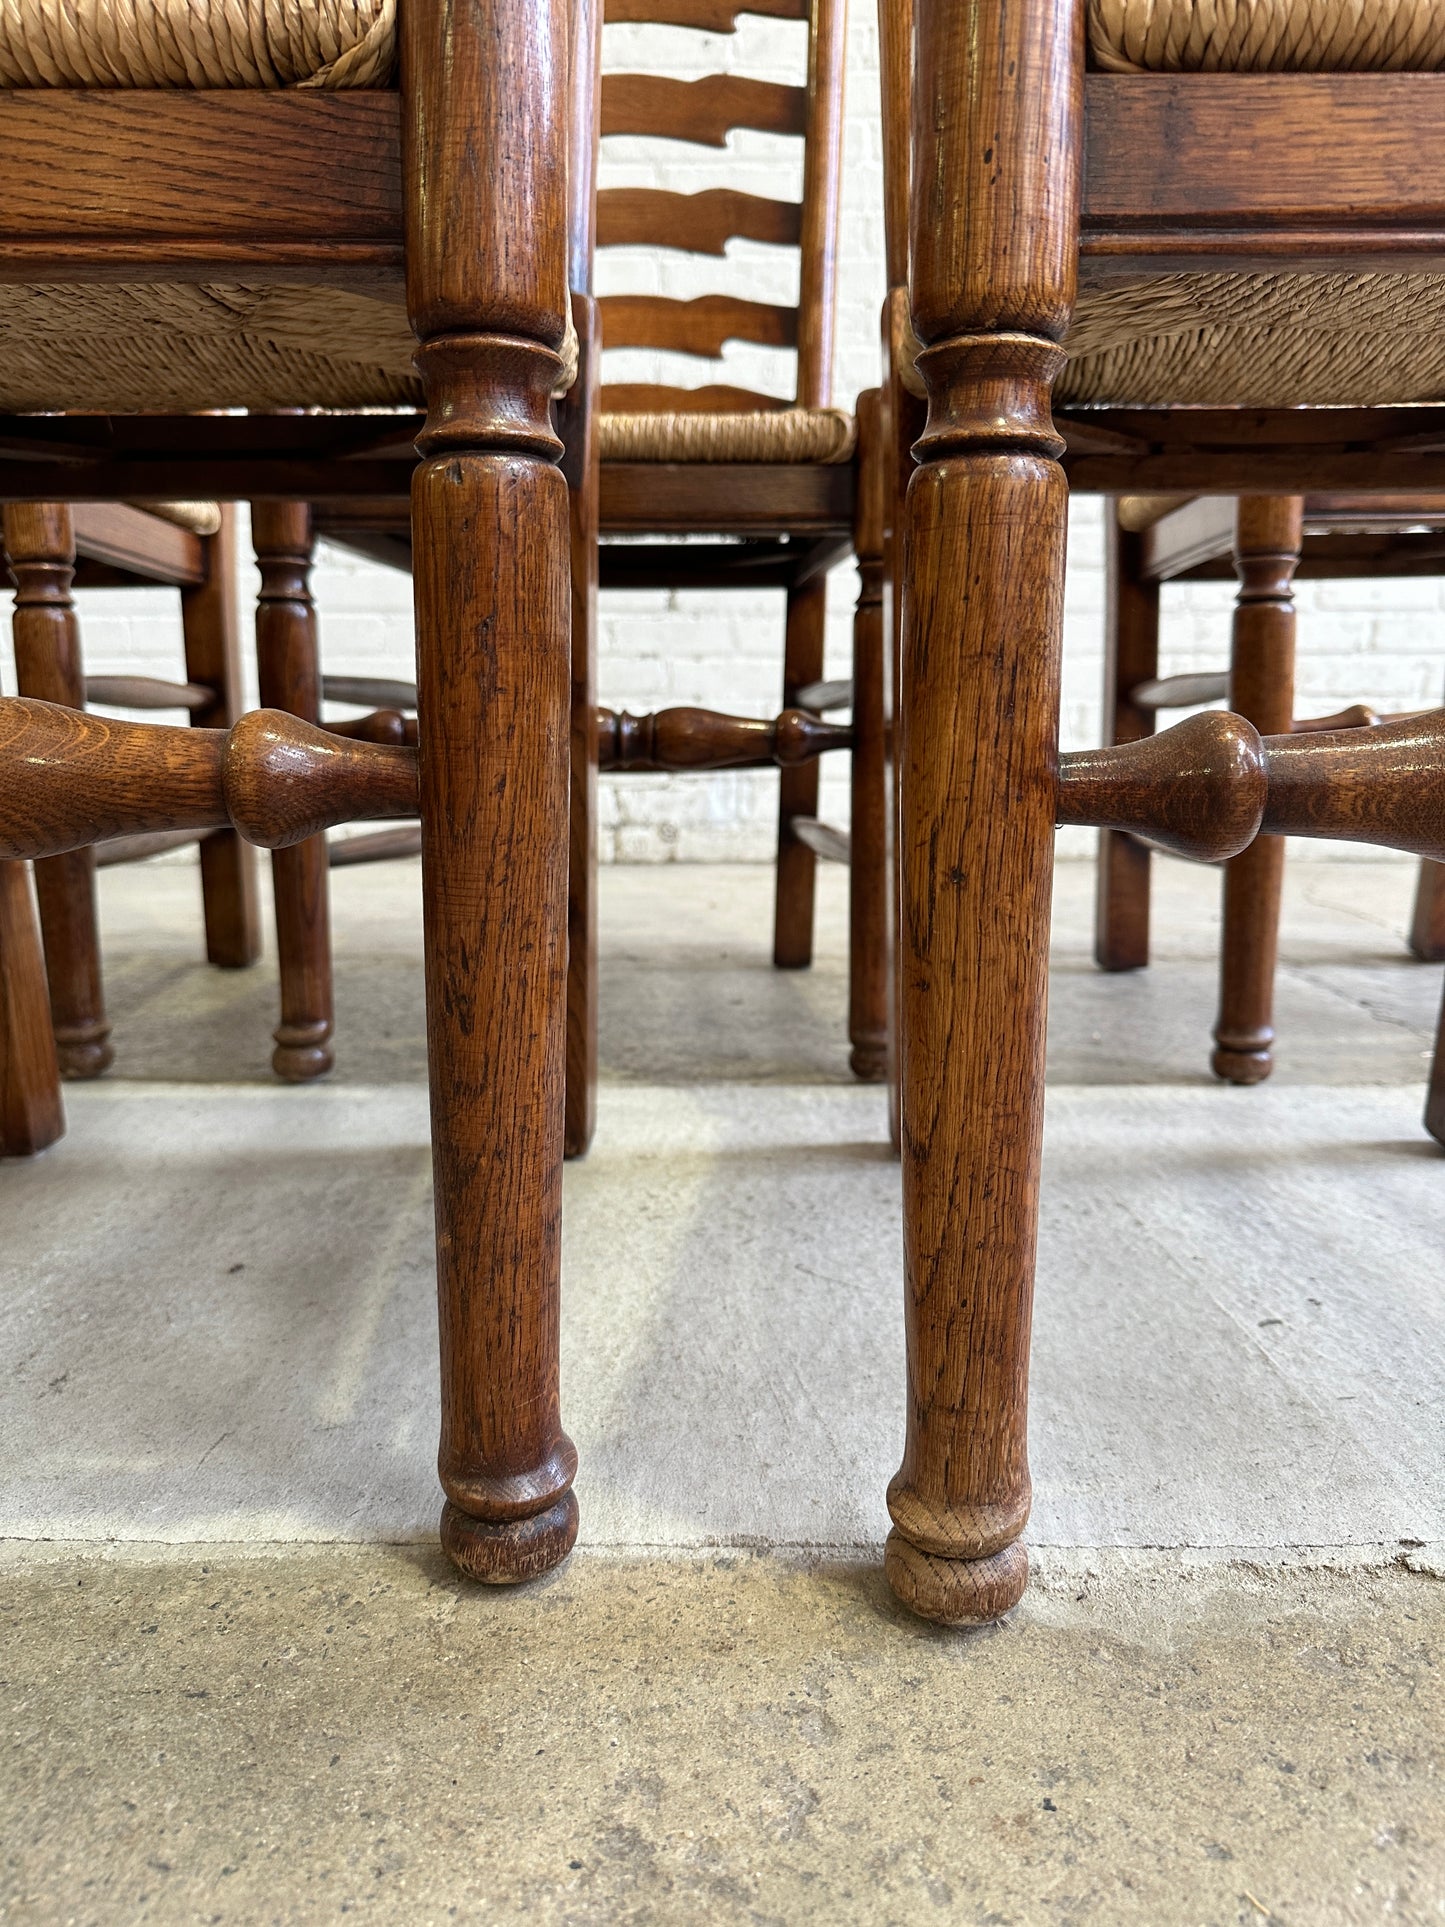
0, 863, 66, 1158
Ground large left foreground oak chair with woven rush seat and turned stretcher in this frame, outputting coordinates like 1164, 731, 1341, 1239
0, 0, 601, 1580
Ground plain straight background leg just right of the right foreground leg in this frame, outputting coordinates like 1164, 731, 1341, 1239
1094, 503, 1160, 969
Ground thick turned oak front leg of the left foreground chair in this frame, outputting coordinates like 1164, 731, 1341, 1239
399, 0, 578, 1584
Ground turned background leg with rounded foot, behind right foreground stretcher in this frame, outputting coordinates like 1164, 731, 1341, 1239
1210, 495, 1304, 1085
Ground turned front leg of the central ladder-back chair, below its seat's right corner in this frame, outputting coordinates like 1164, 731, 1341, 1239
848, 389, 888, 1083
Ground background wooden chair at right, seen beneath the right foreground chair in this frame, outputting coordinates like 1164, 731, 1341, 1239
1094, 495, 1445, 1109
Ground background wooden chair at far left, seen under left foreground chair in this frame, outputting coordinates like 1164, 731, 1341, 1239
4, 503, 260, 1077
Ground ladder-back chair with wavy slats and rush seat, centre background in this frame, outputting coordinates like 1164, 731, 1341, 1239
597, 0, 877, 986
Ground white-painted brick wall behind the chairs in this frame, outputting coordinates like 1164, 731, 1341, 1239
0, 0, 1445, 863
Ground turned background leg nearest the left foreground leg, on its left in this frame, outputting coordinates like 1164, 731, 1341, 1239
250, 501, 333, 1083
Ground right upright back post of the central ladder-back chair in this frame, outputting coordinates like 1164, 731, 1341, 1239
798, 0, 844, 409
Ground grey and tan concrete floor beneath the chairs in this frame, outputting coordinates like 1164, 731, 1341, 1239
0, 863, 1445, 1923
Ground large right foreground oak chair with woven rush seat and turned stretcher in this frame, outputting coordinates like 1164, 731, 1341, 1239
886, 0, 1445, 1623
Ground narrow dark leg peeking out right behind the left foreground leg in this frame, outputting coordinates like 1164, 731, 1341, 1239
559, 295, 601, 1158
